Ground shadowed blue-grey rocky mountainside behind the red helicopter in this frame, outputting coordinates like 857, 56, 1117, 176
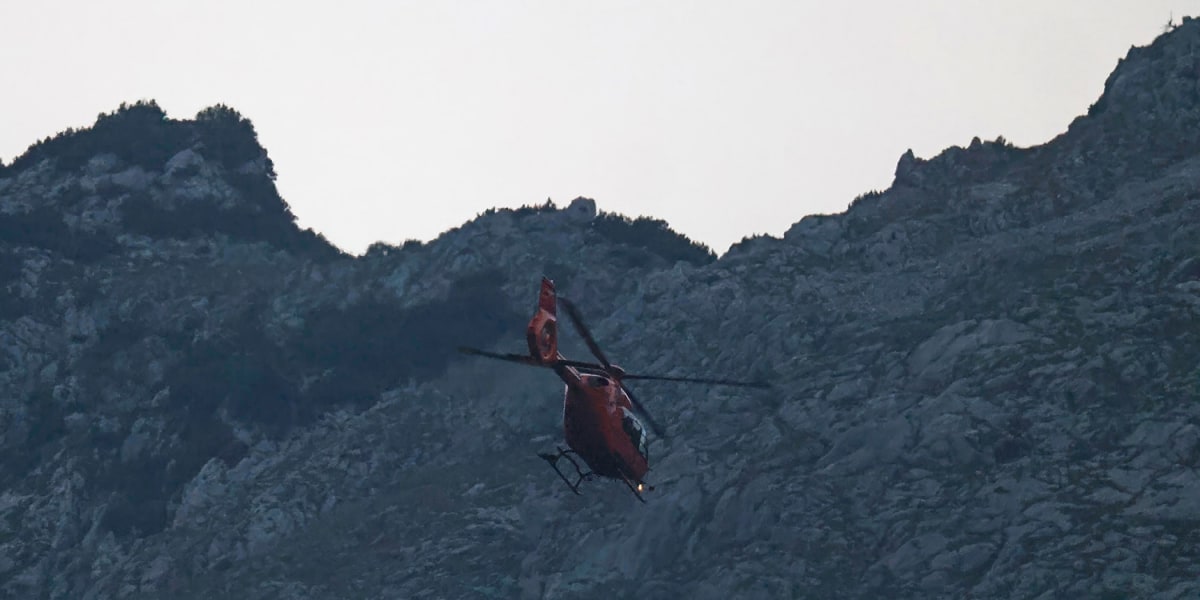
0, 20, 1200, 599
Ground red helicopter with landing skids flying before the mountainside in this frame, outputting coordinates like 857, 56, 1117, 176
458, 277, 768, 503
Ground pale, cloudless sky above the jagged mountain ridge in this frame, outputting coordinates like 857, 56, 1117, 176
0, 0, 1200, 253
